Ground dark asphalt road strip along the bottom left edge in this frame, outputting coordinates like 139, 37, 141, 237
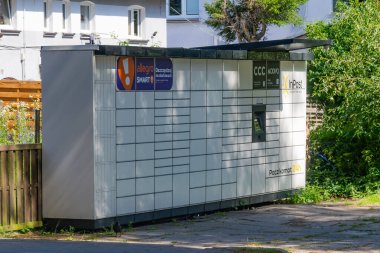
0, 240, 232, 253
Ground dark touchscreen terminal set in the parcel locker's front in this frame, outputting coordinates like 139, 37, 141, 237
252, 105, 266, 142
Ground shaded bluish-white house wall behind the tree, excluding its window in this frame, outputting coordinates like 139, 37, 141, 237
167, 0, 333, 48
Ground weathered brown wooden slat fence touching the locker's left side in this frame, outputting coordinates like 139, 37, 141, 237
0, 144, 42, 231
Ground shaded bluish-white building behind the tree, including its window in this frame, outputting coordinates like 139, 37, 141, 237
166, 0, 335, 48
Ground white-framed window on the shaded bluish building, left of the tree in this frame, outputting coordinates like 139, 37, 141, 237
167, 0, 199, 18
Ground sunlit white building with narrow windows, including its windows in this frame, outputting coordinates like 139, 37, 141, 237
0, 0, 167, 80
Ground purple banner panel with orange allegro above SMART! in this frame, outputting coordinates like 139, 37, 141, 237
136, 58, 154, 90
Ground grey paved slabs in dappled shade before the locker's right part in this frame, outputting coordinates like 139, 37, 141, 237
122, 204, 380, 253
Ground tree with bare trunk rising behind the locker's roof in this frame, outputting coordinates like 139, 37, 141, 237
205, 0, 307, 42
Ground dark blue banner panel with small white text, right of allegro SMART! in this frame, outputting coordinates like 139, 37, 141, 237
155, 58, 173, 90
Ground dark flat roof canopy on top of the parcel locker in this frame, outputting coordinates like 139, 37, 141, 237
42, 39, 331, 61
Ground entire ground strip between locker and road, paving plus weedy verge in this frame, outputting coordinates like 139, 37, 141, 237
0, 203, 380, 253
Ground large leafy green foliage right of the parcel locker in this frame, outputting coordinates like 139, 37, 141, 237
306, 0, 380, 196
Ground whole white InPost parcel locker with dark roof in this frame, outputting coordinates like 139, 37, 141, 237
42, 40, 327, 228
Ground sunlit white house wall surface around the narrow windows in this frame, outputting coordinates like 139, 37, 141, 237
0, 0, 167, 80
